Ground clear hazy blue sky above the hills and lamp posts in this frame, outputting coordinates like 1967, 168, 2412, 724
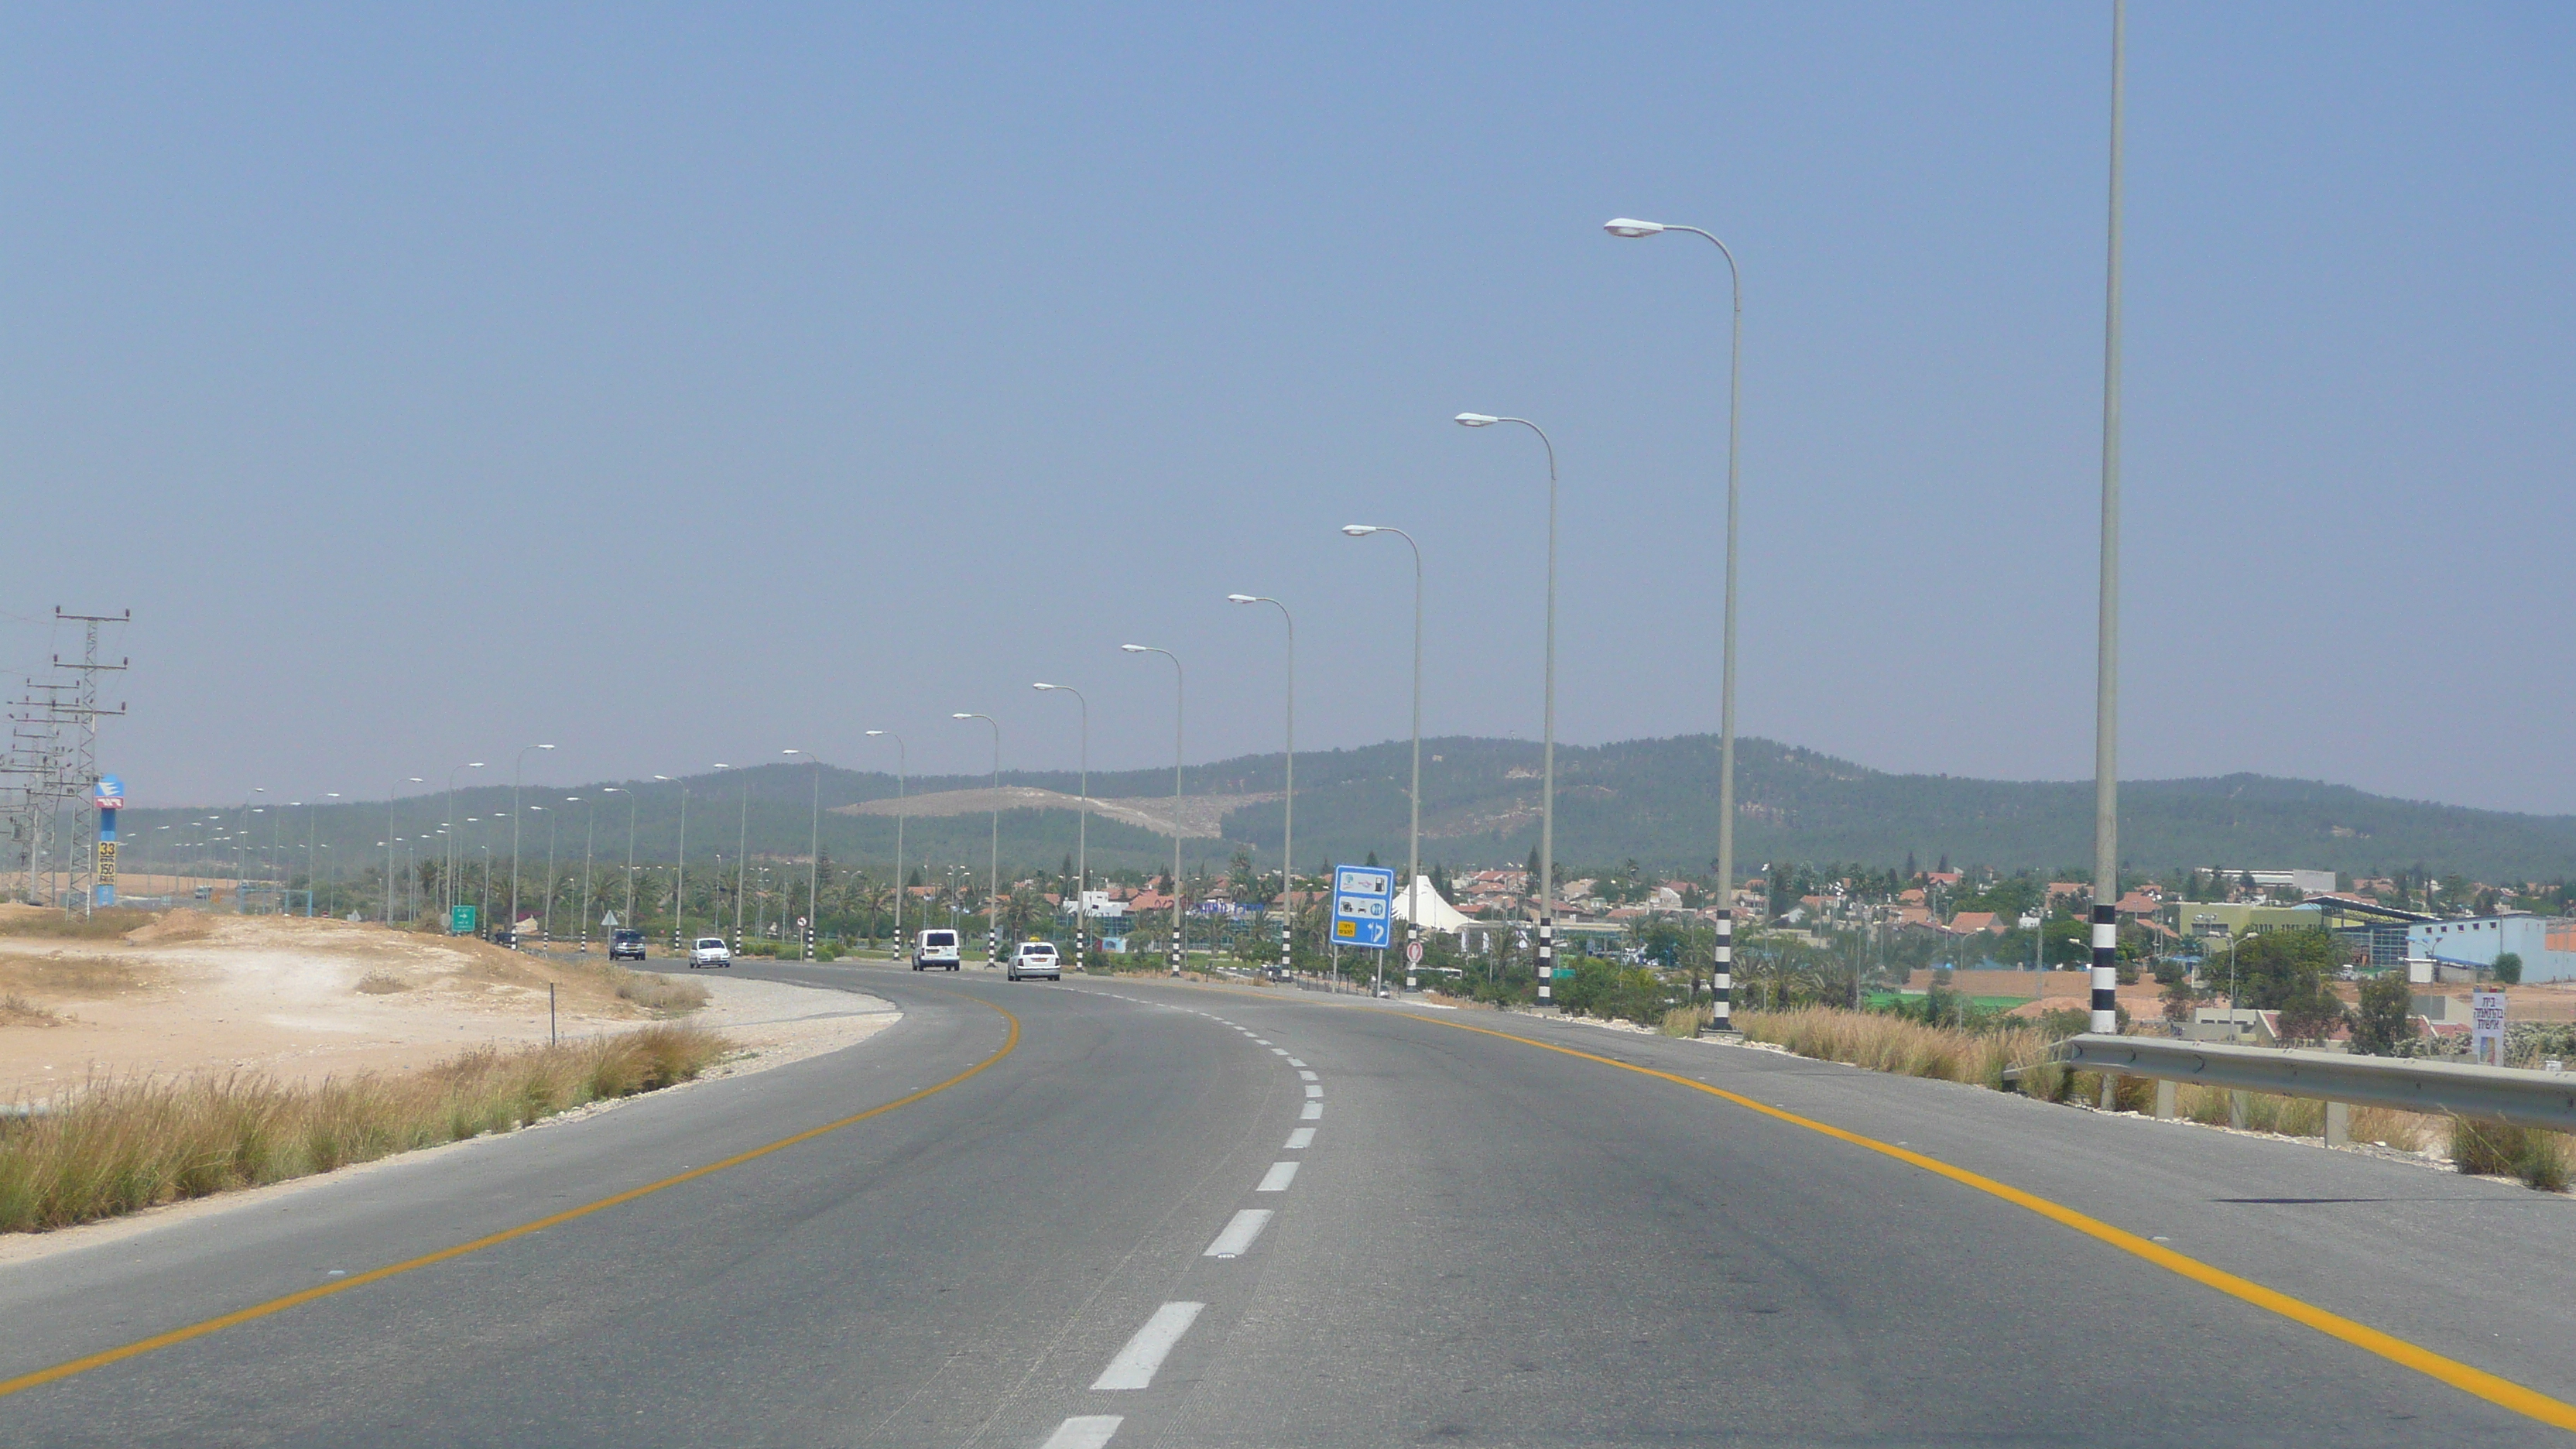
0, 0, 2576, 812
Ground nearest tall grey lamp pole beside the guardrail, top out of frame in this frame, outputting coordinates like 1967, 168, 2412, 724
2091, 0, 2128, 1036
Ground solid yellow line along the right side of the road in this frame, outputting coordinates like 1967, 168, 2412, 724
1416, 1016, 2576, 1428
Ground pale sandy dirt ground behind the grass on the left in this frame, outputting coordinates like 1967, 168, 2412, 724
0, 907, 891, 1101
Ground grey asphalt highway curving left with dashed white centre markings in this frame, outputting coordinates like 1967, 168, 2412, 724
0, 967, 2576, 1449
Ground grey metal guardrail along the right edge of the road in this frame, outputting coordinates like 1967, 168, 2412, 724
2053, 1034, 2576, 1132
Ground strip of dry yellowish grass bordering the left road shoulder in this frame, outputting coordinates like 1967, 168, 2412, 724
0, 1026, 726, 1232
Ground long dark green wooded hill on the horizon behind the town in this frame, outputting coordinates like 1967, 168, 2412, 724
124, 735, 2576, 882
